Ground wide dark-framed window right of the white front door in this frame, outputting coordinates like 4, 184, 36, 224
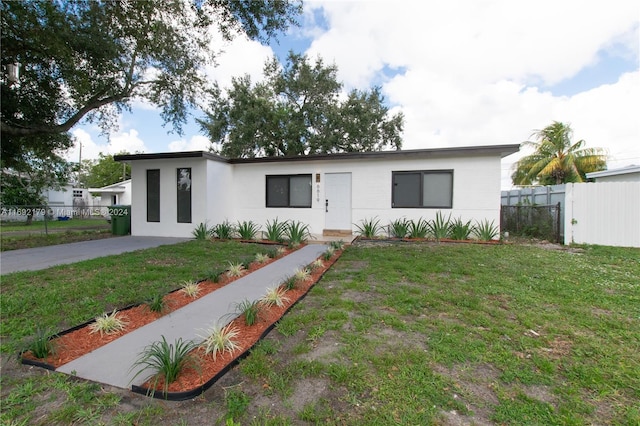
391, 170, 453, 209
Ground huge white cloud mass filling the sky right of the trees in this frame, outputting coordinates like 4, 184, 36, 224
307, 0, 640, 186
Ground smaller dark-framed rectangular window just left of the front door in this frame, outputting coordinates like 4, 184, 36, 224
266, 174, 312, 208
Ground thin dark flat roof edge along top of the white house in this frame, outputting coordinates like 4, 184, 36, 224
114, 144, 520, 164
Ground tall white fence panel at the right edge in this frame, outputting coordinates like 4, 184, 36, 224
564, 182, 640, 247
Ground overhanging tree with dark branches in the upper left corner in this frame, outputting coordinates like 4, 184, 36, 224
0, 0, 302, 168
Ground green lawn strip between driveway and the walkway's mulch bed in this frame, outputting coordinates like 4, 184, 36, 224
0, 241, 256, 352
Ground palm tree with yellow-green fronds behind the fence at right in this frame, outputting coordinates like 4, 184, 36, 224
511, 121, 607, 185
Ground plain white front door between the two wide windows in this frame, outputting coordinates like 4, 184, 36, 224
324, 173, 351, 231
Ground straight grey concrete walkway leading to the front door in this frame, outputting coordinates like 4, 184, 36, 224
56, 244, 328, 388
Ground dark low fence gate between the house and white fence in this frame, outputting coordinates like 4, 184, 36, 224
500, 203, 564, 243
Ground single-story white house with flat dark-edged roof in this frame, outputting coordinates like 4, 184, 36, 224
115, 145, 519, 237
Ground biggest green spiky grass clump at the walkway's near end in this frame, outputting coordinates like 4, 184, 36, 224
131, 336, 200, 393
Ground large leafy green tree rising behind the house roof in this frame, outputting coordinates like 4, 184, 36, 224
198, 52, 404, 158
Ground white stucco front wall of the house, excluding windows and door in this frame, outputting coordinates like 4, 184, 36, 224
126, 150, 500, 237
